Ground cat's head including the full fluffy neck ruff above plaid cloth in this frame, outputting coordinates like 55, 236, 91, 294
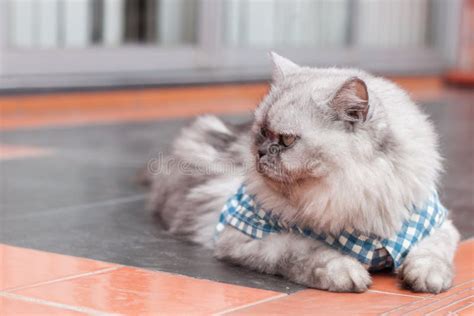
247, 54, 442, 236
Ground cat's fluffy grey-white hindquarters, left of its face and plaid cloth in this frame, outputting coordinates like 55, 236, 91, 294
148, 115, 249, 243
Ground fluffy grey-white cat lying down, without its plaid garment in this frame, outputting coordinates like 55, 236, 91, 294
148, 53, 459, 293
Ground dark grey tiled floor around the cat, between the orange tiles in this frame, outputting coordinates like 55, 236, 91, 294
0, 99, 474, 292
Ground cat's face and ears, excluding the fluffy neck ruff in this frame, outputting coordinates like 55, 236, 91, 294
252, 53, 386, 187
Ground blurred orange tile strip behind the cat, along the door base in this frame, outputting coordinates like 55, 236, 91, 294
0, 77, 442, 130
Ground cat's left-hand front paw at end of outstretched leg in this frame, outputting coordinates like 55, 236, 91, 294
313, 257, 372, 293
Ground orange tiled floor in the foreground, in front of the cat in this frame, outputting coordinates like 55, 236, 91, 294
0, 240, 474, 315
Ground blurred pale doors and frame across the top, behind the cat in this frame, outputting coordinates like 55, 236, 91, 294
0, 0, 474, 90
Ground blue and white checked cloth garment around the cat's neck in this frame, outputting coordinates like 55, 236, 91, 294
216, 185, 447, 270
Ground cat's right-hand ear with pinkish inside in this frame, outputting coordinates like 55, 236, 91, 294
330, 77, 369, 123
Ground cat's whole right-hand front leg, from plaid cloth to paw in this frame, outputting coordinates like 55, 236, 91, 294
399, 220, 459, 293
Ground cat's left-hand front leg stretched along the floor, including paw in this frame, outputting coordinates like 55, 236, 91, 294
215, 227, 371, 292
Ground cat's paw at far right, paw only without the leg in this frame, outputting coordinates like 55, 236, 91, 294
400, 255, 453, 293
